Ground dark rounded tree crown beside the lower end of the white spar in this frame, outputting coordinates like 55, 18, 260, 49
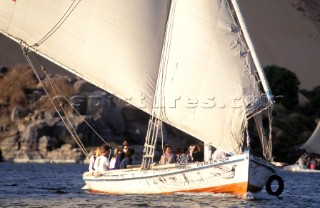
264, 65, 300, 110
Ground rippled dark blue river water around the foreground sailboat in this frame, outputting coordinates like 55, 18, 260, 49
0, 163, 320, 207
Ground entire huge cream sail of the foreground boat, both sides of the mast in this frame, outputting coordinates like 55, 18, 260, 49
0, 0, 268, 153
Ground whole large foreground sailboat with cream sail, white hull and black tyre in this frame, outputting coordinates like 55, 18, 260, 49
0, 0, 283, 196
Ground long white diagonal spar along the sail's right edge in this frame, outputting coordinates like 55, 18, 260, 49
231, 0, 274, 103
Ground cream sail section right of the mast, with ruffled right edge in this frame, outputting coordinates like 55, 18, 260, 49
155, 0, 259, 153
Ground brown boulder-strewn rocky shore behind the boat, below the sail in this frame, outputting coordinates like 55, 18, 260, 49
0, 65, 192, 163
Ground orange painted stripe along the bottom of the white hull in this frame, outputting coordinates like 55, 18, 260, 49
90, 182, 248, 195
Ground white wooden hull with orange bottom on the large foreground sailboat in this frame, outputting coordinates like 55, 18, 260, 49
83, 154, 275, 195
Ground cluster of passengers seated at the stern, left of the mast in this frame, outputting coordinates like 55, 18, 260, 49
89, 140, 134, 173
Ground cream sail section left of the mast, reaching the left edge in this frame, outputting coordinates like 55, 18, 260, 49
0, 0, 169, 113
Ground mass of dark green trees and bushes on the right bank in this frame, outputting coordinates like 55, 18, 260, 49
264, 65, 320, 163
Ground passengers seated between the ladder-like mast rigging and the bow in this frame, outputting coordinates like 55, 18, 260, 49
159, 143, 228, 165
